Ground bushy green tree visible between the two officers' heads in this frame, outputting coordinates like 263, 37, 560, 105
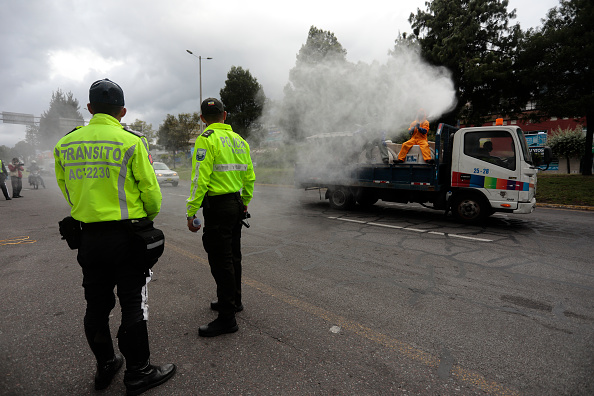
157, 112, 200, 168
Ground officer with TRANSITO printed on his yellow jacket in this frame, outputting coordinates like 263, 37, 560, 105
54, 79, 175, 395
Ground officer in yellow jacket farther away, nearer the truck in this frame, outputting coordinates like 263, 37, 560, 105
186, 98, 256, 337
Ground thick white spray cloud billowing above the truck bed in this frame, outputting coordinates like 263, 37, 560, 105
264, 47, 456, 144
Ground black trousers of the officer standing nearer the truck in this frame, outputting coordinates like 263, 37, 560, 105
202, 193, 244, 317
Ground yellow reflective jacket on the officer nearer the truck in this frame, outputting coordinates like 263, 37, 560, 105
186, 123, 256, 217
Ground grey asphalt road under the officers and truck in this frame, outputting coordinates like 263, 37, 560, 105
0, 178, 594, 395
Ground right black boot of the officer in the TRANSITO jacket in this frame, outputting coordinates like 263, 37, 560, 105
118, 320, 175, 395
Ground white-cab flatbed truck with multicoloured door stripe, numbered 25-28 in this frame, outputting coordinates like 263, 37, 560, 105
295, 124, 551, 223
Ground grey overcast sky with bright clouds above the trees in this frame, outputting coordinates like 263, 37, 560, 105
0, 0, 558, 147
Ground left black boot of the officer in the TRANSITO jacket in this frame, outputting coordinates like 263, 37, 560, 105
85, 325, 124, 390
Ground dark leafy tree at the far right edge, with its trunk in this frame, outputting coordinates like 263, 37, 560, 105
520, 0, 594, 175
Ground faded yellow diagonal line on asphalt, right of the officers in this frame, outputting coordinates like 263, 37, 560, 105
165, 242, 519, 396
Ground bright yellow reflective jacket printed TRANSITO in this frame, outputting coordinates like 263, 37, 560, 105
54, 114, 162, 223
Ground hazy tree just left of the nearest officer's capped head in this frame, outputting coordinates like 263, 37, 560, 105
38, 88, 84, 149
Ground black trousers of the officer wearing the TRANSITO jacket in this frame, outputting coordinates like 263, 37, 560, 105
77, 221, 151, 367
